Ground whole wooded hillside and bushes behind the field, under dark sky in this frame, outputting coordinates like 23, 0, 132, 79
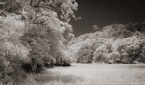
68, 22, 145, 64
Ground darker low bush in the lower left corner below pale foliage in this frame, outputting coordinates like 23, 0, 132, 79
0, 49, 27, 85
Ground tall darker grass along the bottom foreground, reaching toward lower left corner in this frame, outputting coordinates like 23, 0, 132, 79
0, 71, 83, 85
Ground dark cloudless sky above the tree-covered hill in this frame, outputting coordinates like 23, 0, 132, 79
71, 0, 145, 36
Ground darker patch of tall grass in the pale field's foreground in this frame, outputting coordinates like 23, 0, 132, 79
35, 71, 83, 85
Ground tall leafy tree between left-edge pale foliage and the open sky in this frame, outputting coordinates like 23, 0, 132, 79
16, 0, 77, 72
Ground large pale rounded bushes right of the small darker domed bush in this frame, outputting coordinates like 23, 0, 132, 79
93, 37, 145, 64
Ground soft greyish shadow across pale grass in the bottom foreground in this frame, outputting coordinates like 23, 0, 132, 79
35, 71, 83, 83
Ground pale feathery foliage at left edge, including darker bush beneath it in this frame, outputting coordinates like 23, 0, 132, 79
0, 16, 29, 84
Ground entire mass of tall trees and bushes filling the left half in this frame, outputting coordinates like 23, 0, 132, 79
0, 0, 77, 85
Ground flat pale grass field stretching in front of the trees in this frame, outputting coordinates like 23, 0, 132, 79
35, 64, 145, 85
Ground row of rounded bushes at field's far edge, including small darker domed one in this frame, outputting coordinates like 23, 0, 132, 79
77, 37, 145, 64
